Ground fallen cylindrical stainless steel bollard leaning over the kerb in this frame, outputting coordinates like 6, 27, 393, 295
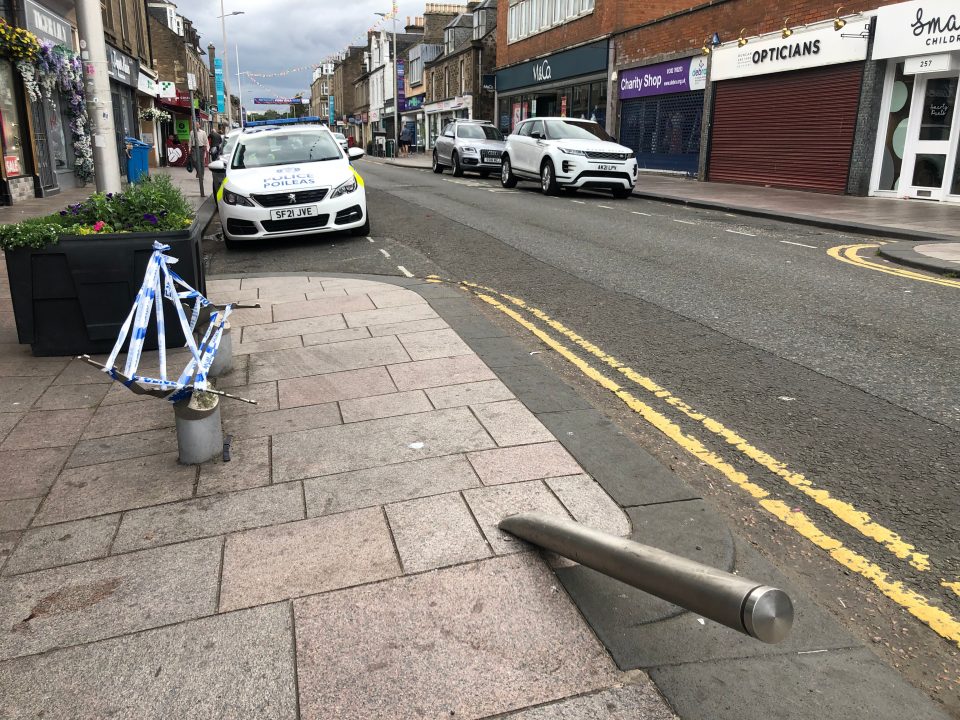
499, 512, 793, 643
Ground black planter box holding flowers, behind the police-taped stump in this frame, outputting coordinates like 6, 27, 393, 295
5, 218, 209, 356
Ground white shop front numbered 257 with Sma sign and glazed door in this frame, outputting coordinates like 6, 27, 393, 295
870, 0, 960, 203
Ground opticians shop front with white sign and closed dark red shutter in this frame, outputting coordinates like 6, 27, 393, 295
707, 18, 869, 194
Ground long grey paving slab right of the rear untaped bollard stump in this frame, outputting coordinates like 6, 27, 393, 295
249, 336, 410, 383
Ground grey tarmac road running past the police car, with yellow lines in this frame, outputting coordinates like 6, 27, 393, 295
205, 160, 960, 714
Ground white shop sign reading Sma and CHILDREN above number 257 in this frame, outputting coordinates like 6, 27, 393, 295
873, 0, 960, 60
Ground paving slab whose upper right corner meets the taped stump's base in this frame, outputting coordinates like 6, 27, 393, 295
34, 453, 197, 525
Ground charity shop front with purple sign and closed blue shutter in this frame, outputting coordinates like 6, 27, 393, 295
617, 55, 707, 175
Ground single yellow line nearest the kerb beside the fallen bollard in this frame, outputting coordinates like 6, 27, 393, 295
476, 293, 960, 646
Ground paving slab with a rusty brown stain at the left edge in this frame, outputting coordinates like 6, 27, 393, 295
0, 538, 222, 659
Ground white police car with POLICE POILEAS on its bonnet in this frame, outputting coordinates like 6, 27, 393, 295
217, 125, 370, 247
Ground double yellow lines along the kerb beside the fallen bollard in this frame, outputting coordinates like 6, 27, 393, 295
427, 276, 960, 646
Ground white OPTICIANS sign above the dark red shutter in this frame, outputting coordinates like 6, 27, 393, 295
710, 20, 869, 81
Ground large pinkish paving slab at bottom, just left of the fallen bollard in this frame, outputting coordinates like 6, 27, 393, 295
294, 555, 617, 720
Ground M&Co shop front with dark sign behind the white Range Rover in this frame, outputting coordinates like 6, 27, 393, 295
496, 40, 609, 133
